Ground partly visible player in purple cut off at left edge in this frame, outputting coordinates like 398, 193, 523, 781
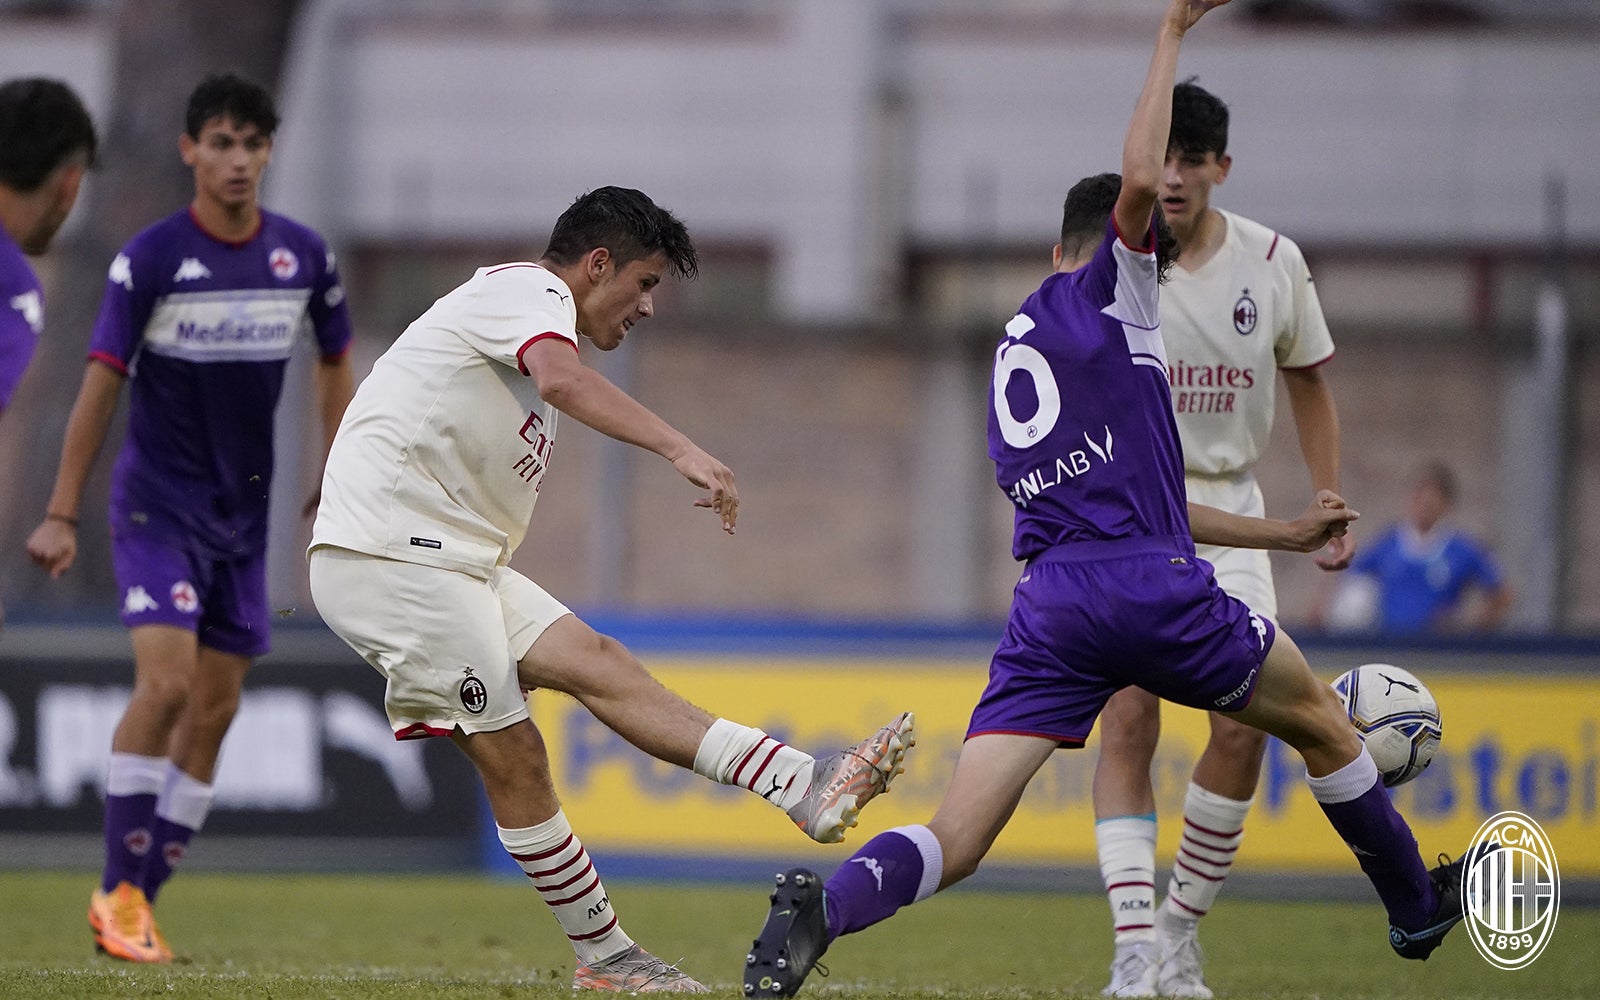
0, 77, 96, 414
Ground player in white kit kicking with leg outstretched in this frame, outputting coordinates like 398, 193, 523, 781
309, 187, 915, 992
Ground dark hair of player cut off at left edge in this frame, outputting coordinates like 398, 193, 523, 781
0, 77, 98, 194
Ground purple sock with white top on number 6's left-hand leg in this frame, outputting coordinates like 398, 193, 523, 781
824, 826, 944, 942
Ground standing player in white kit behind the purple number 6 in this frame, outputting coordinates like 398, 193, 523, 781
1094, 82, 1355, 998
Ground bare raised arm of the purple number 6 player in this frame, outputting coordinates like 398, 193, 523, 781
1112, 0, 1227, 246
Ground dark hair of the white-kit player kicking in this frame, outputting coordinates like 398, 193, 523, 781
544, 187, 699, 278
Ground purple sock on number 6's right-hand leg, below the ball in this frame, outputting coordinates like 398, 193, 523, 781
1306, 747, 1438, 931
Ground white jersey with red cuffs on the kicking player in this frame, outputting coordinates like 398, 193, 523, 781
310, 262, 578, 579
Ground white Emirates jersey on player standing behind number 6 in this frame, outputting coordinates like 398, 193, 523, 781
1162, 210, 1333, 475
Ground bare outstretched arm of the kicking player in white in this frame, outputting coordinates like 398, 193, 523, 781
522, 338, 739, 534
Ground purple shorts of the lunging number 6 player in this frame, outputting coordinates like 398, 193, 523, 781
966, 538, 1277, 747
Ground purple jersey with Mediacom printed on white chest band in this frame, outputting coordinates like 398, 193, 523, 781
90, 210, 350, 555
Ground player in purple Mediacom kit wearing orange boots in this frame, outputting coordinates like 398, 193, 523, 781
27, 75, 352, 962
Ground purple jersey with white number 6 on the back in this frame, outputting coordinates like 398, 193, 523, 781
989, 222, 1189, 560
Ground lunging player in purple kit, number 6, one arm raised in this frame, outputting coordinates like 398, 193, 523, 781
744, 0, 1474, 997
